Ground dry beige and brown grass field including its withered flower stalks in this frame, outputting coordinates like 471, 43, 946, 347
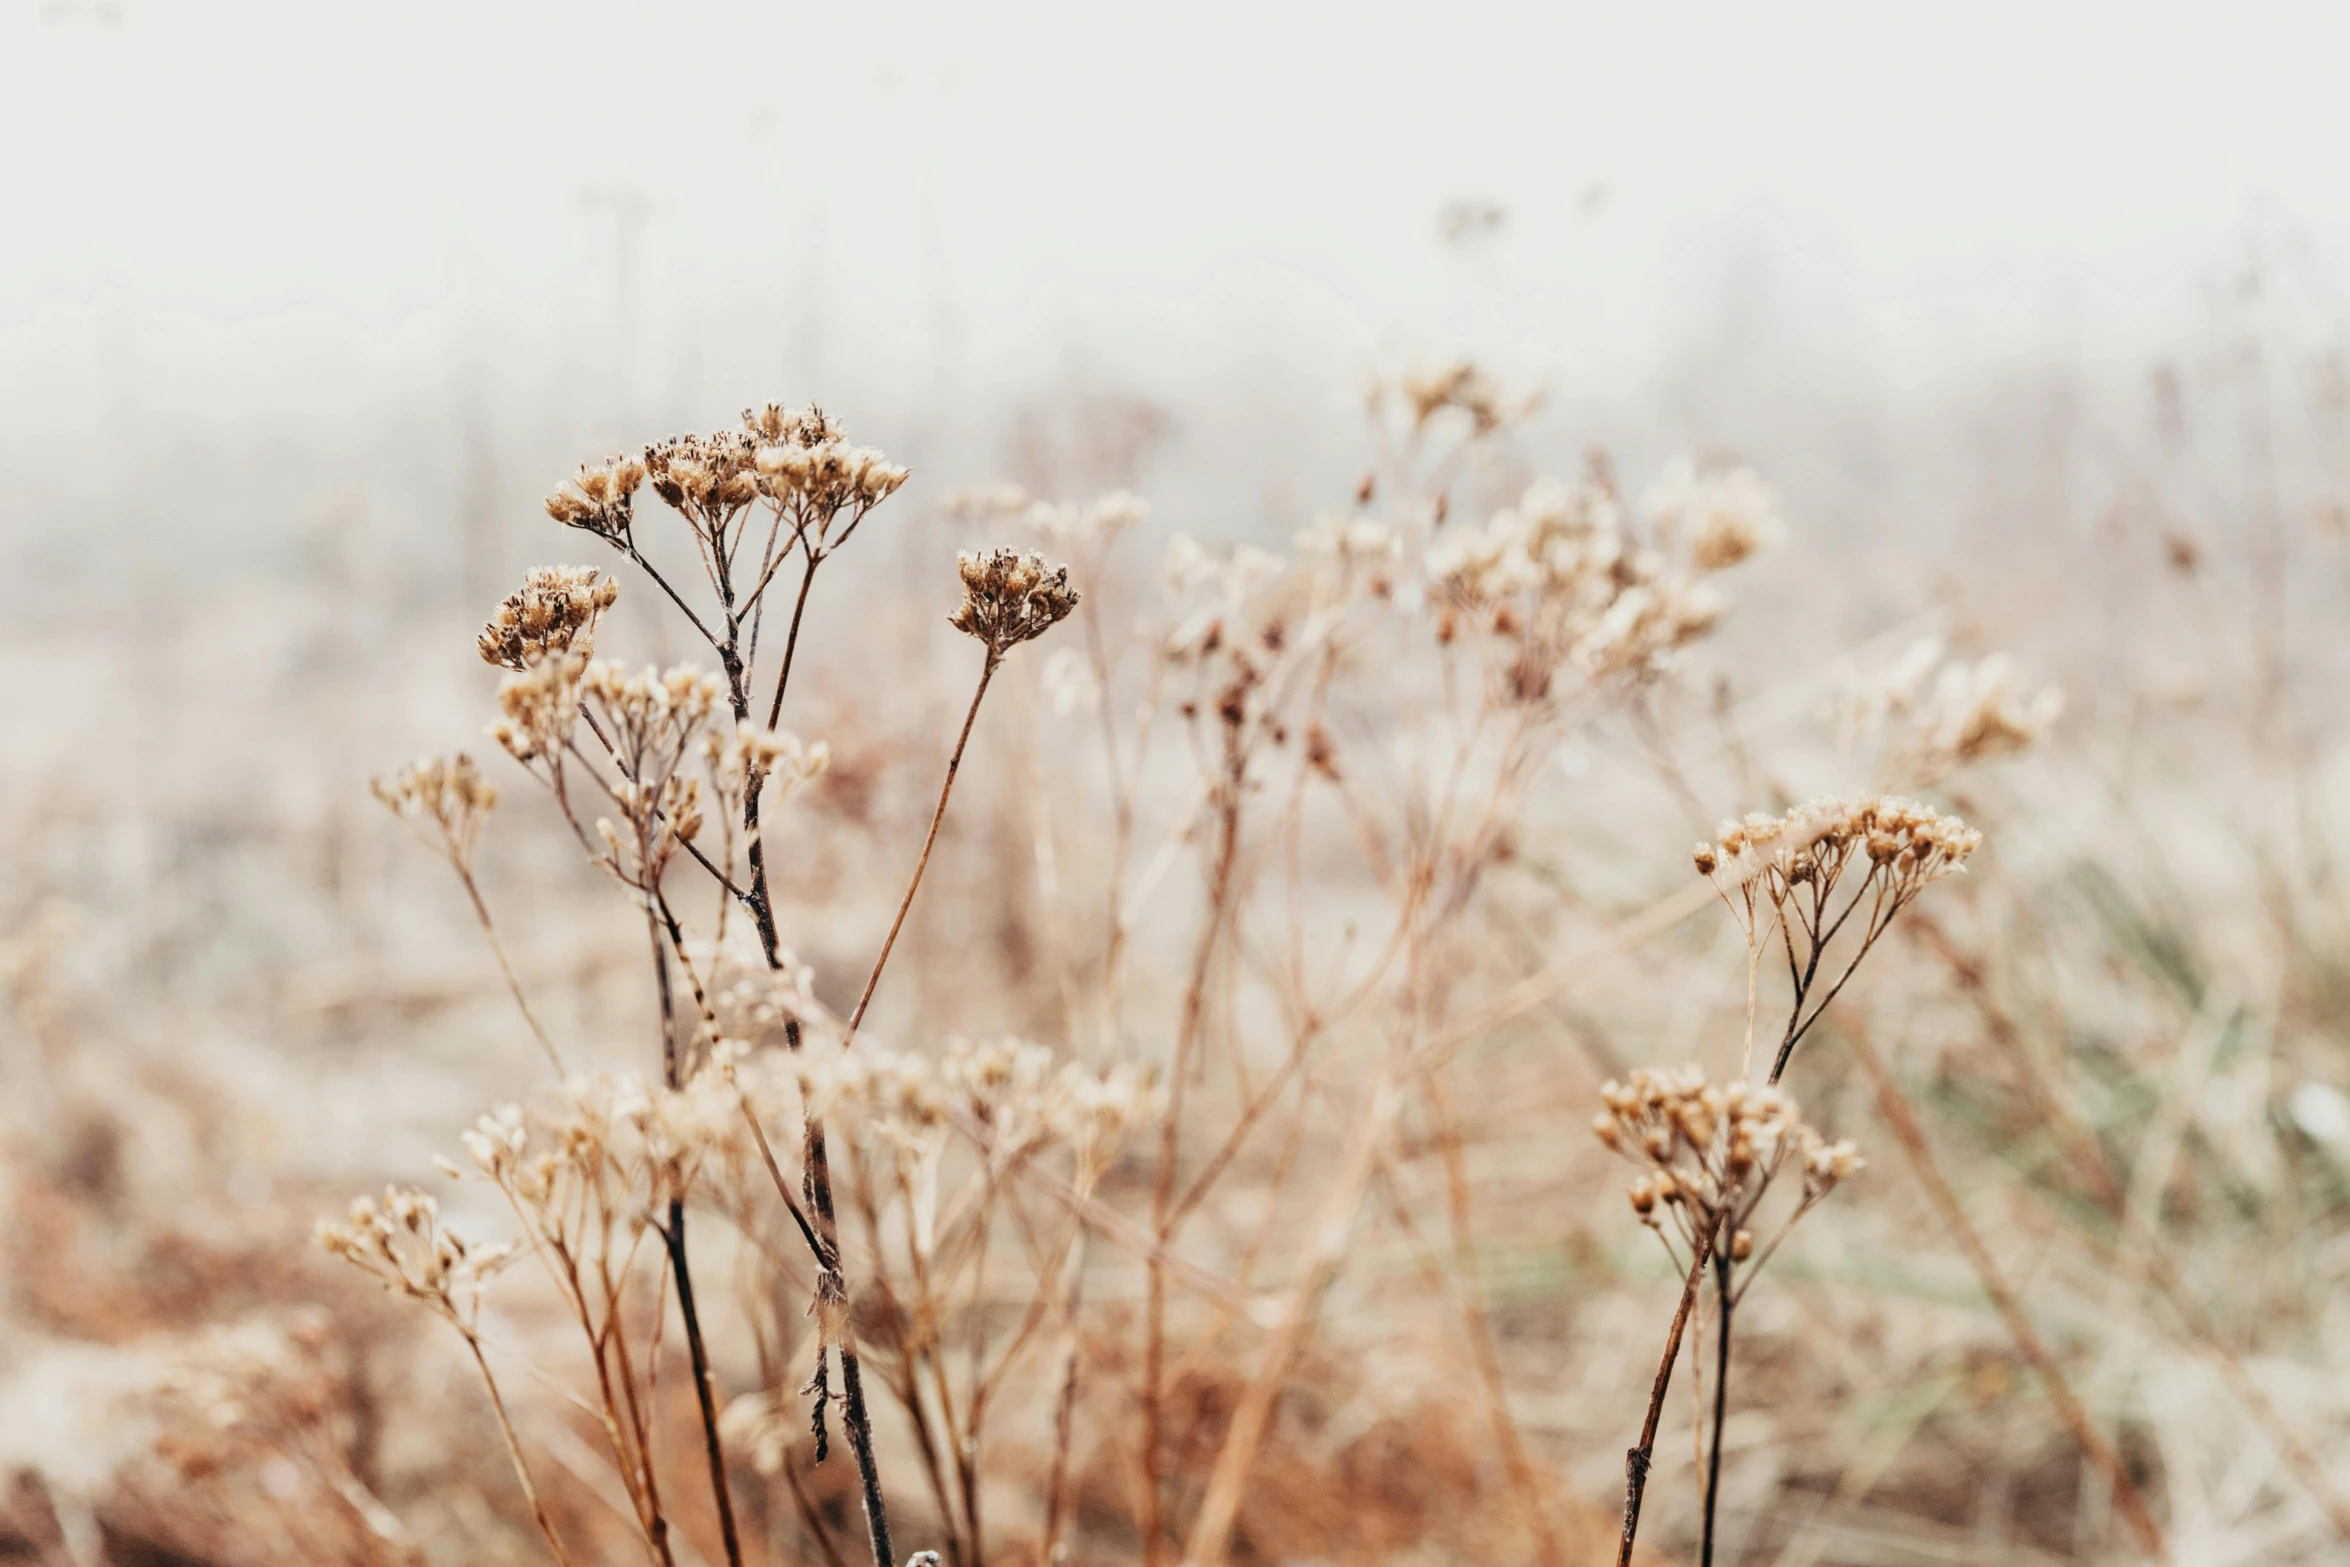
0, 331, 2350, 1567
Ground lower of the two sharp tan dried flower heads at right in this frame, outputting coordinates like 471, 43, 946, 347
1591, 1067, 1861, 1299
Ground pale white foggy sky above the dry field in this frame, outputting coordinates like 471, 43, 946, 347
0, 0, 2350, 505
